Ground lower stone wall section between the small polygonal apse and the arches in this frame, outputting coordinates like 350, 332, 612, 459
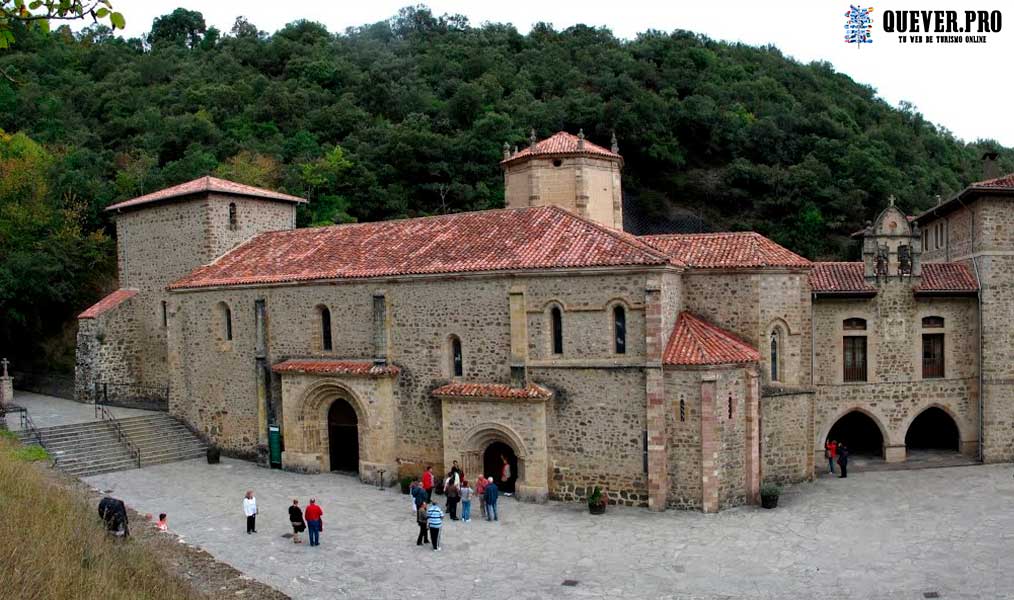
761, 388, 815, 483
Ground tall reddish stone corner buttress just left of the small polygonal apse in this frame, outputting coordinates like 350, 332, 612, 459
644, 280, 669, 511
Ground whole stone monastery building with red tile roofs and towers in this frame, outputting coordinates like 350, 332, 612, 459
77, 132, 1014, 512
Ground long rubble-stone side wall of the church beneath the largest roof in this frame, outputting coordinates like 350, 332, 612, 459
170, 271, 669, 505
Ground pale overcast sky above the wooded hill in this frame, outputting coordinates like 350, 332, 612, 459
91, 0, 1014, 146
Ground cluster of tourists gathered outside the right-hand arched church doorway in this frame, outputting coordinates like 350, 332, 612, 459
409, 459, 510, 551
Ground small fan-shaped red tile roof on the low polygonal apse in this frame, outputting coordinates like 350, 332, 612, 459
662, 310, 761, 365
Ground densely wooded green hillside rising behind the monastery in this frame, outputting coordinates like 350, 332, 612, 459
0, 7, 1014, 366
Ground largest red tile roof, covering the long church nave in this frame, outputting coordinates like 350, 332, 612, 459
169, 207, 672, 289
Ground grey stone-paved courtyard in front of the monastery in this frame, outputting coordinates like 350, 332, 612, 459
85, 460, 1014, 600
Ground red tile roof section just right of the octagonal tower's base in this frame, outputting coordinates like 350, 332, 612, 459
640, 231, 811, 269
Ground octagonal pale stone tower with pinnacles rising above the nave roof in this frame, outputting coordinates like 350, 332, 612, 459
500, 130, 624, 230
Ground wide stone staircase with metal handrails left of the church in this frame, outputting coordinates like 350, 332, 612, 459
21, 413, 207, 477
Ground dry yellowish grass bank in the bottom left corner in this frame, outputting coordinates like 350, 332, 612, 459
0, 436, 202, 600
